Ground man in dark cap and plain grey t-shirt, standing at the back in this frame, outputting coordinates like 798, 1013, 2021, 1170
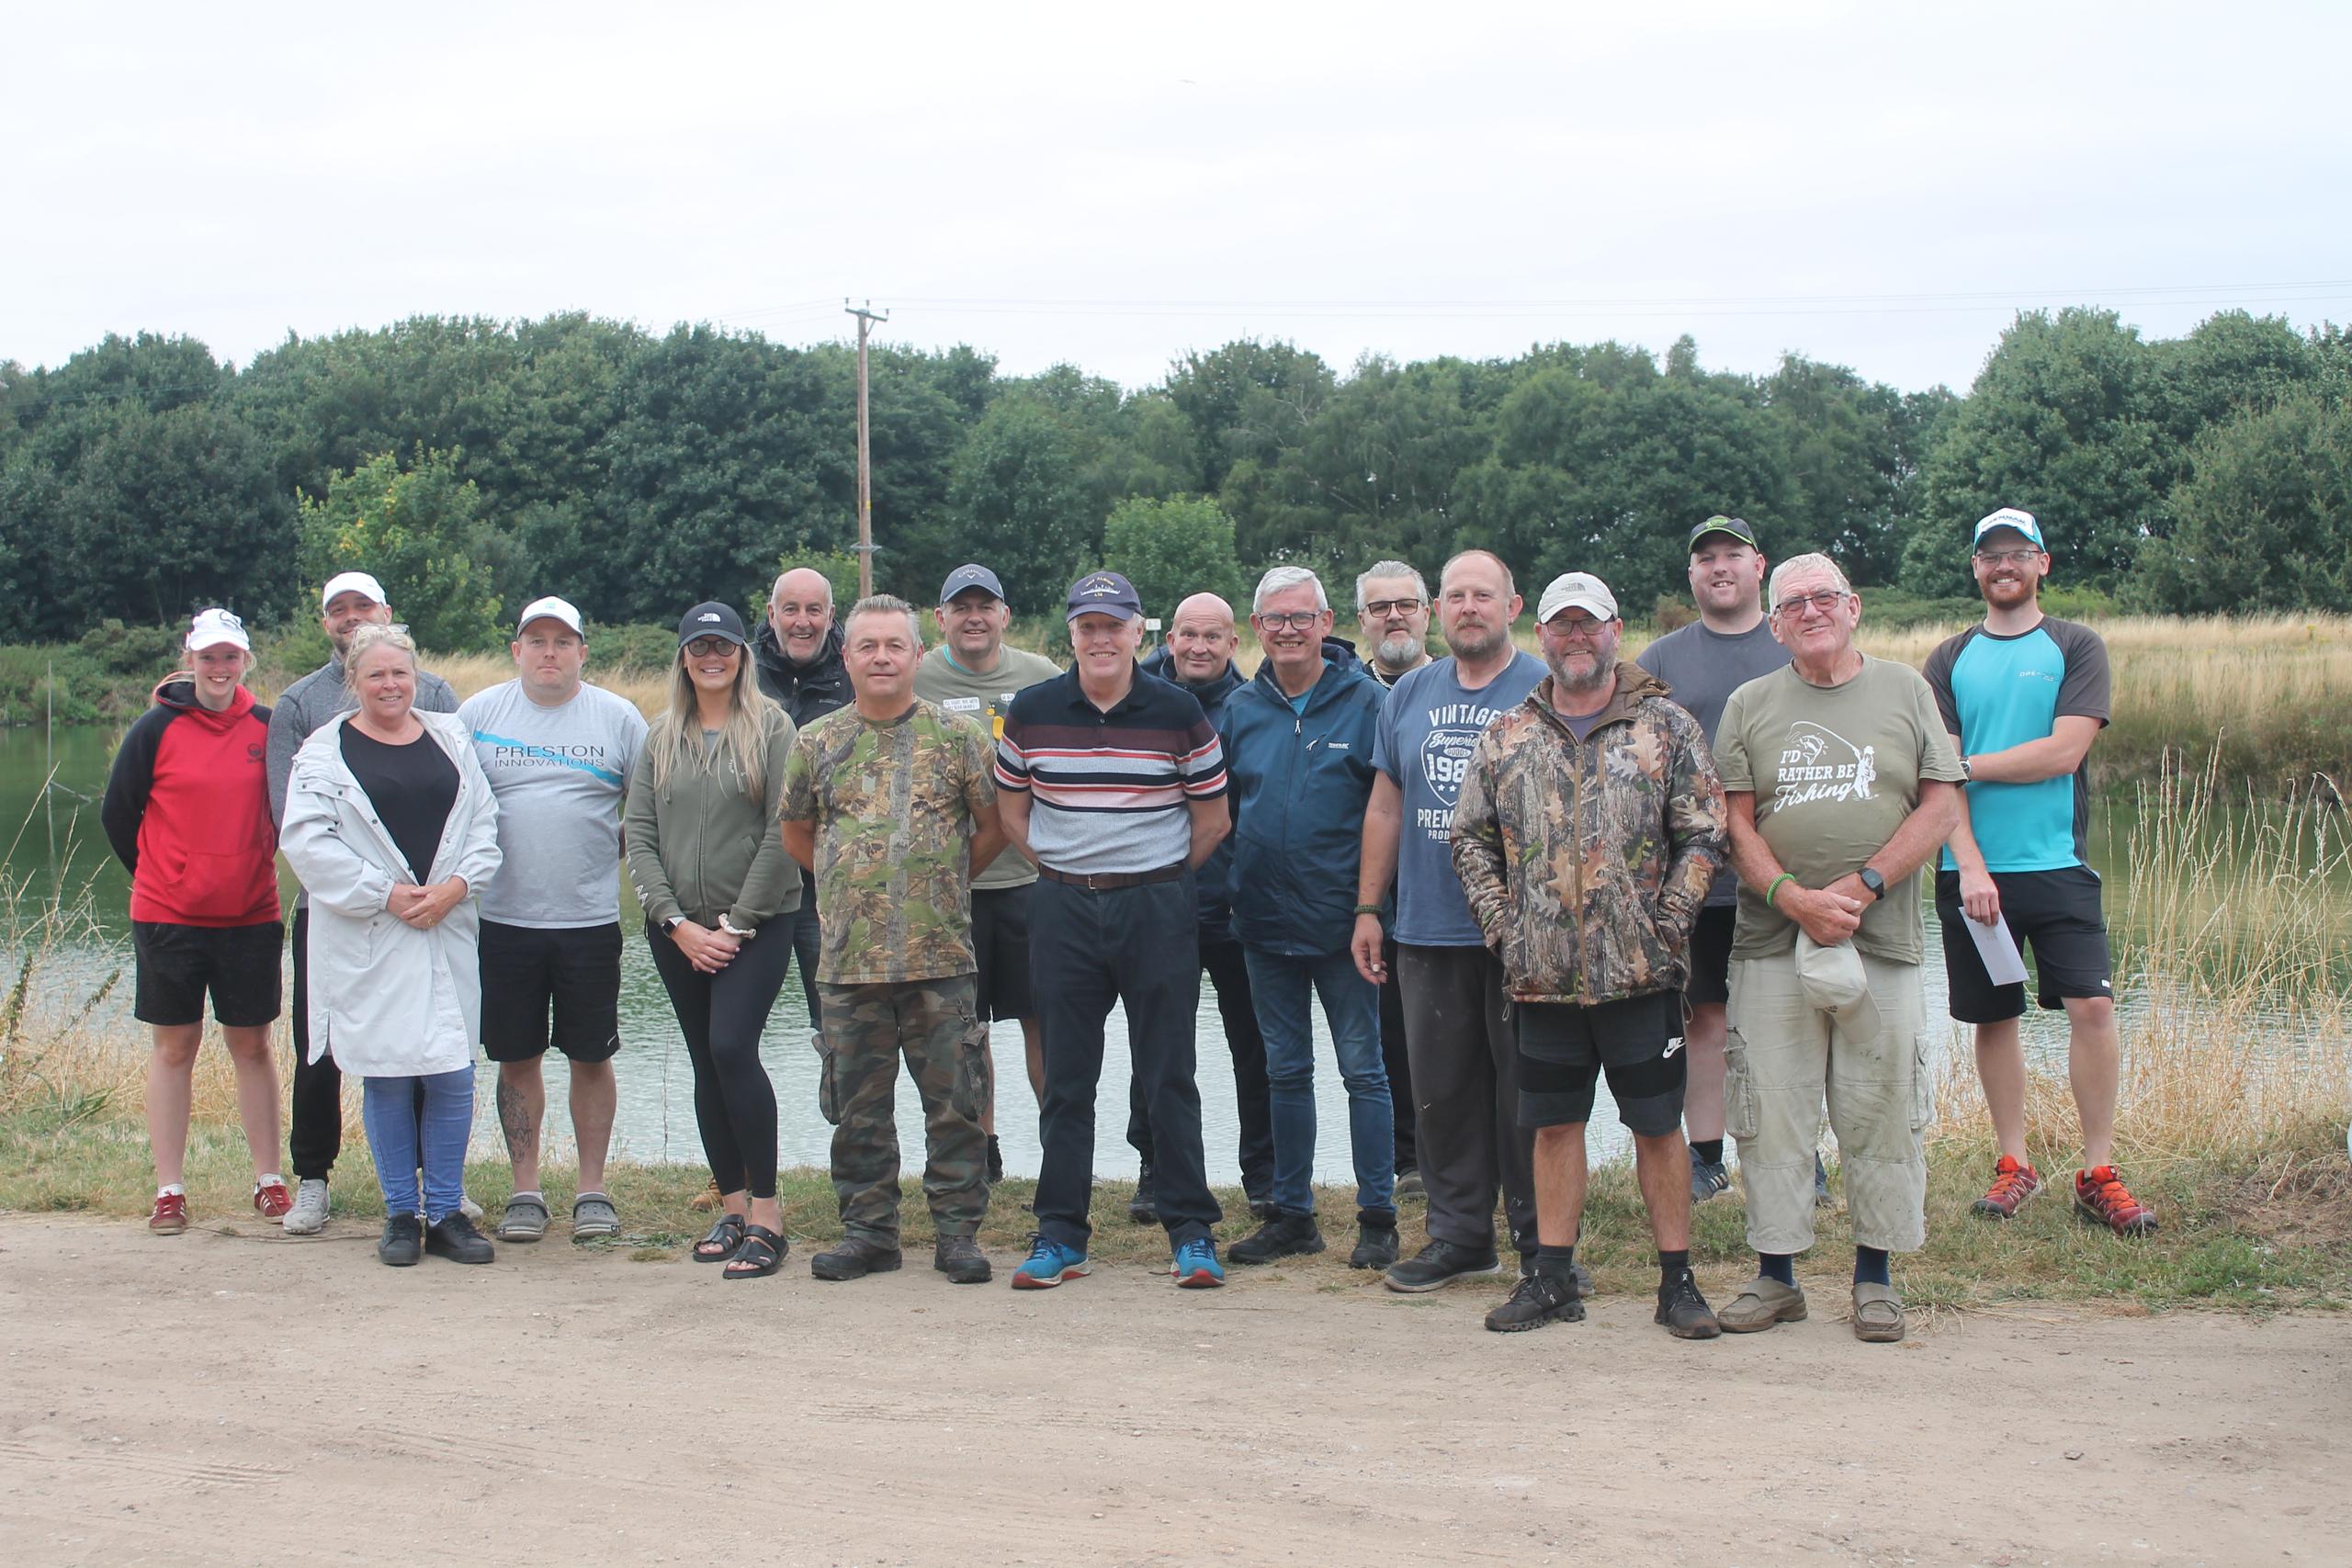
1634, 517, 1787, 1203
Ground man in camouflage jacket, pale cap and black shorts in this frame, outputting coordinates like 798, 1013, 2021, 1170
1453, 571, 1729, 1340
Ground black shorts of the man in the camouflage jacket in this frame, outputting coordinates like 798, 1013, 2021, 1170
1510, 992, 1689, 1138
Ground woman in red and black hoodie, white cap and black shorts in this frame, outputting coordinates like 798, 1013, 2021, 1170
99, 609, 294, 1236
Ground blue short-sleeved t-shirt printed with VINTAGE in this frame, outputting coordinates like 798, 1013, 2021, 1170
1371, 651, 1545, 947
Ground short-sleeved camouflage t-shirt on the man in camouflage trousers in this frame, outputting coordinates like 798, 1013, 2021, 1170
778, 698, 997, 985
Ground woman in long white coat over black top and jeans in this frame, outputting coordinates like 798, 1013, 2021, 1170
277, 626, 499, 1267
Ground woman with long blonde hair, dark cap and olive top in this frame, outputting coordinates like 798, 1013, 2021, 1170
626, 604, 799, 1279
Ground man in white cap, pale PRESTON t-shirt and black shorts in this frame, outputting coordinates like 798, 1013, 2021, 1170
457, 594, 644, 1241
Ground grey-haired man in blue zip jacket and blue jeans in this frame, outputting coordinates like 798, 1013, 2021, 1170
1223, 567, 1397, 1269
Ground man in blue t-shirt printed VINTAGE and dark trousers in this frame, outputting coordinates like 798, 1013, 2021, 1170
1352, 550, 1571, 1291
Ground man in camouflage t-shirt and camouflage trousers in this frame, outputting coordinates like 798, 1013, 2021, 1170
781, 594, 1004, 1283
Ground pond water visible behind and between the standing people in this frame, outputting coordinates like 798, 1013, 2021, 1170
0, 727, 2333, 1184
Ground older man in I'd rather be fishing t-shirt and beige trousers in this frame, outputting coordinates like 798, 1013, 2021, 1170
1714, 555, 1962, 1342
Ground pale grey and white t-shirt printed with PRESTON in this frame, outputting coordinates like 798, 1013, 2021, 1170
457, 680, 644, 931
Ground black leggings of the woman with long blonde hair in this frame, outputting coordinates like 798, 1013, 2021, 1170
644, 915, 793, 1199
